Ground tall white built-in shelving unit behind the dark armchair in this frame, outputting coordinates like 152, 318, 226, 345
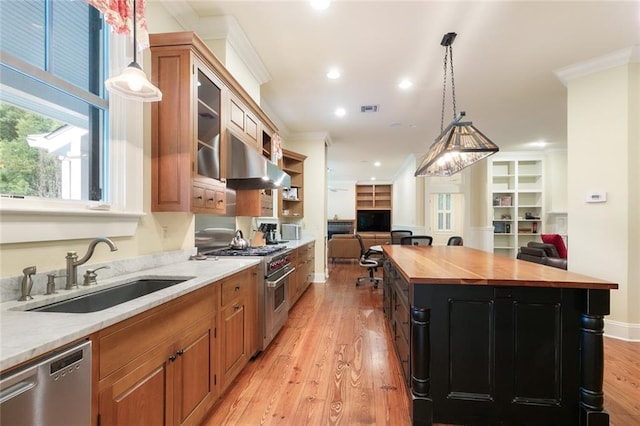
489, 157, 544, 257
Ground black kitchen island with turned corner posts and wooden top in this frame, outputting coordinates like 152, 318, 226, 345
382, 245, 618, 425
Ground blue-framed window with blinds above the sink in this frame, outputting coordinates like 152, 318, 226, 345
0, 0, 108, 201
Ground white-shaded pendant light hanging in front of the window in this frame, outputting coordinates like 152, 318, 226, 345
104, 0, 162, 102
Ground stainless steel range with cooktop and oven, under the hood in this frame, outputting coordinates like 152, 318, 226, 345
203, 245, 295, 350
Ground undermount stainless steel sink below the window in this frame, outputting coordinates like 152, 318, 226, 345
29, 278, 187, 314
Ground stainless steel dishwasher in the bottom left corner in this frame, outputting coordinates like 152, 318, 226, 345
0, 341, 91, 426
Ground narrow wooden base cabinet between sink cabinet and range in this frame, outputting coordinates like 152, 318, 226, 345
220, 267, 258, 388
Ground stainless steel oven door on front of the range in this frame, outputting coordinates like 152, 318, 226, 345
264, 266, 296, 348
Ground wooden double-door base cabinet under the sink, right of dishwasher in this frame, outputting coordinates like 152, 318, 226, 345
93, 285, 219, 425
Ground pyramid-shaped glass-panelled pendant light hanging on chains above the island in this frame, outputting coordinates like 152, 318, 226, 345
415, 33, 498, 176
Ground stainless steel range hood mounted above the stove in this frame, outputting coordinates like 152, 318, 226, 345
226, 132, 291, 189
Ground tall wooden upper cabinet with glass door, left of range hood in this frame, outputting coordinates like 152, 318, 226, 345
150, 33, 226, 214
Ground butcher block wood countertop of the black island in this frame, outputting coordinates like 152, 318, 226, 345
382, 245, 618, 290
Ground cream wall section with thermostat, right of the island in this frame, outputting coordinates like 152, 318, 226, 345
567, 54, 640, 340
